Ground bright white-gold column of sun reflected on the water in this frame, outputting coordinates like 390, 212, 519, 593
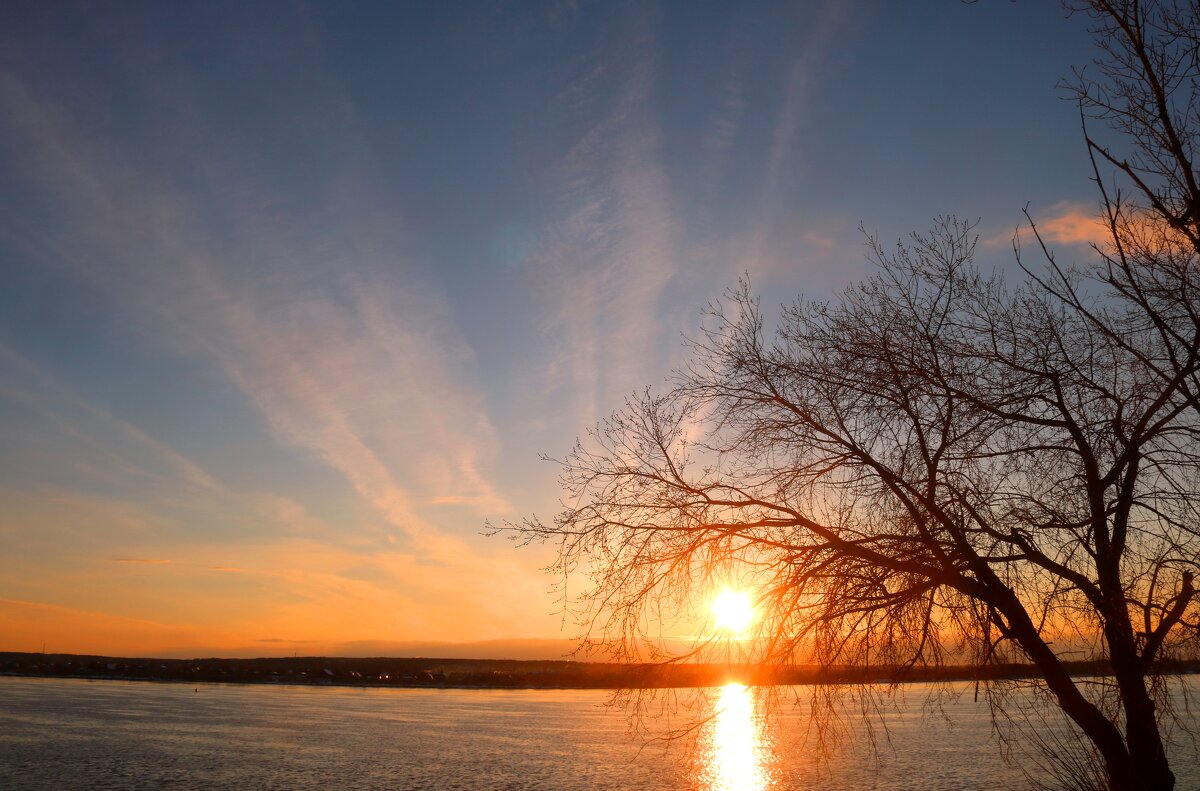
701, 684, 770, 791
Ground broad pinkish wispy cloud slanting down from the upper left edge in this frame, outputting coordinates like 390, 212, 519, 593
0, 49, 511, 533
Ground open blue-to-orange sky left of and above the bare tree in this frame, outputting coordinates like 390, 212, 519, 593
0, 0, 1096, 655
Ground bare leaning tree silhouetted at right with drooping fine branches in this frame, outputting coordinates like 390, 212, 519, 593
514, 0, 1200, 790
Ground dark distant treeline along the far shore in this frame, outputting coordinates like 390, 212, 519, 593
0, 652, 1200, 689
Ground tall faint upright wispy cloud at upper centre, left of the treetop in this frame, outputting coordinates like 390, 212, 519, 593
532, 6, 677, 425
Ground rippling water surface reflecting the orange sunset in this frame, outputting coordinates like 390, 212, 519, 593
0, 678, 1200, 791
